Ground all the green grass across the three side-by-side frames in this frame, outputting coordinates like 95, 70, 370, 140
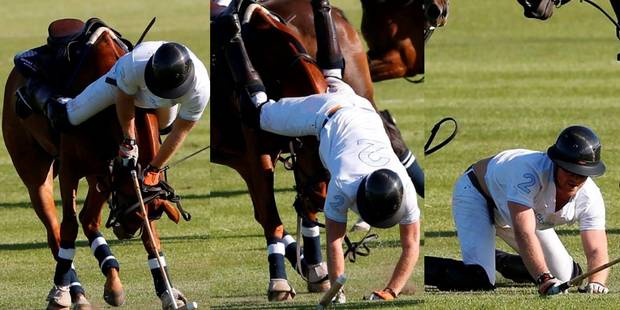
0, 0, 620, 309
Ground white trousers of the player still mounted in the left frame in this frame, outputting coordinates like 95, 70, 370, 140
66, 71, 179, 129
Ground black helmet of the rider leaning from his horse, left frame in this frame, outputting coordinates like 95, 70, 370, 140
144, 42, 194, 99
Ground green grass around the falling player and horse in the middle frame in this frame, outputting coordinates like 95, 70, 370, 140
209, 0, 424, 309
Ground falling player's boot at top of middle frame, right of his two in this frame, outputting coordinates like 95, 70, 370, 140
312, 0, 344, 70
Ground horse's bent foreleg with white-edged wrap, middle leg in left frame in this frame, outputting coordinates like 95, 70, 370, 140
80, 177, 125, 307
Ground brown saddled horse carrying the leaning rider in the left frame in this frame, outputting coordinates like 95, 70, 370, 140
2, 20, 184, 308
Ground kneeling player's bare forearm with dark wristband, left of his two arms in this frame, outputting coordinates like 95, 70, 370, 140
508, 201, 559, 294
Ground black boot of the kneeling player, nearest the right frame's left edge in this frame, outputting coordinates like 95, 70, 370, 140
424, 256, 495, 291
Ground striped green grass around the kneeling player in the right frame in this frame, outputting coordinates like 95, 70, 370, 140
423, 0, 620, 309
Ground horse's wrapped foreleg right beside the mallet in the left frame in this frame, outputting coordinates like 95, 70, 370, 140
141, 221, 187, 309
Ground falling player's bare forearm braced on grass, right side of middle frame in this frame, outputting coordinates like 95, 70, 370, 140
384, 221, 420, 297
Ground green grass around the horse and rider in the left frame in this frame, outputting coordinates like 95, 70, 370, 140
0, 0, 210, 309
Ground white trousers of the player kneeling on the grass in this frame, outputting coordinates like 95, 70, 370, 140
452, 175, 573, 285
